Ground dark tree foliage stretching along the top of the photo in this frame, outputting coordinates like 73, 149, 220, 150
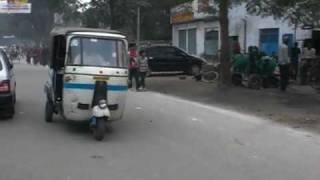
0, 0, 320, 46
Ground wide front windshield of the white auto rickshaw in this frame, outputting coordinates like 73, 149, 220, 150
68, 37, 127, 67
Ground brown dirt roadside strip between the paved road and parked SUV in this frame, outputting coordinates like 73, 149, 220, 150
147, 75, 320, 133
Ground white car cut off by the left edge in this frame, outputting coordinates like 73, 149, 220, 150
0, 49, 16, 118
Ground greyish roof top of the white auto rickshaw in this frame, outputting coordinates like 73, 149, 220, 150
51, 27, 122, 36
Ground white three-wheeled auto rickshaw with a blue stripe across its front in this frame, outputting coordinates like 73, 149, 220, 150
45, 28, 128, 141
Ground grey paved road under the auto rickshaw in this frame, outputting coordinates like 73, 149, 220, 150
0, 65, 320, 180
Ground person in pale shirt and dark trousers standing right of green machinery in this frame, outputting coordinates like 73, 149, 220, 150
278, 38, 290, 91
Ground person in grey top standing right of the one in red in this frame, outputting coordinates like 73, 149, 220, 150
138, 50, 149, 90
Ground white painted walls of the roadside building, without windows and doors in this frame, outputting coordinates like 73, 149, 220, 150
172, 1, 312, 55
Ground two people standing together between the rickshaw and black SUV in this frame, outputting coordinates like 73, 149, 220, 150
129, 49, 149, 91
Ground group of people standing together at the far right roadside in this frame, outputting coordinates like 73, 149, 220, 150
278, 38, 316, 91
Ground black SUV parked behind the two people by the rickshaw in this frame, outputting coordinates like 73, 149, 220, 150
145, 46, 204, 75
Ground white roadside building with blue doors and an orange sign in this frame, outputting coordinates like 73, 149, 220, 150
171, 0, 319, 56
